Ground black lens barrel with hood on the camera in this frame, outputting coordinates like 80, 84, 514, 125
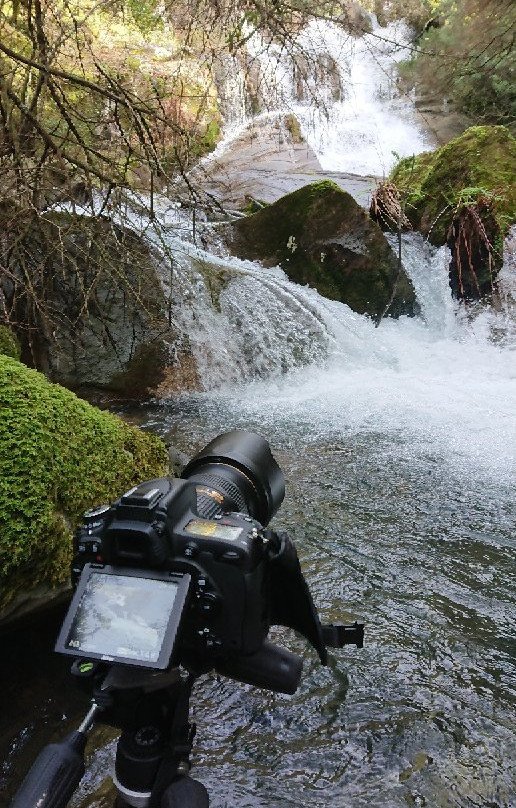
181, 430, 285, 525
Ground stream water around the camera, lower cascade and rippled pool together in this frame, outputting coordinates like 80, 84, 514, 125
0, 14, 516, 808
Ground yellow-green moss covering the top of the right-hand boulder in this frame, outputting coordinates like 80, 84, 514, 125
390, 126, 516, 244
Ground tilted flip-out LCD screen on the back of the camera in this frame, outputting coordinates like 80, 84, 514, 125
56, 565, 190, 669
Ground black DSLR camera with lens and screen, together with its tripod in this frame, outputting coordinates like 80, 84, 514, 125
12, 431, 363, 808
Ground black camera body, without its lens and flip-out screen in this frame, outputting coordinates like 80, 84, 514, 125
72, 477, 271, 660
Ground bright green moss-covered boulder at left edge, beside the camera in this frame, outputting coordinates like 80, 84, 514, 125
0, 356, 168, 623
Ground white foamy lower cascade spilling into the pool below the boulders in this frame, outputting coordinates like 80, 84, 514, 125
153, 224, 516, 477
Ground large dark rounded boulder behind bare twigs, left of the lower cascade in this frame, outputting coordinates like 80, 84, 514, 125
2, 212, 195, 399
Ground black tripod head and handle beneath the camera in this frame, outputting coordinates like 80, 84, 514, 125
11, 660, 209, 808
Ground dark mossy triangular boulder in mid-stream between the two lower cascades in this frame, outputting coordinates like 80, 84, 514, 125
229, 180, 417, 319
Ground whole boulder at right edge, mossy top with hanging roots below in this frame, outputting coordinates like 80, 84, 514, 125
386, 126, 516, 299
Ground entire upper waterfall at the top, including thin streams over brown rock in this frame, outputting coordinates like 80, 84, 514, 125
212, 19, 434, 176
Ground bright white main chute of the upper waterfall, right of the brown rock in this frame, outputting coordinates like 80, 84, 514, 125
295, 21, 433, 175
